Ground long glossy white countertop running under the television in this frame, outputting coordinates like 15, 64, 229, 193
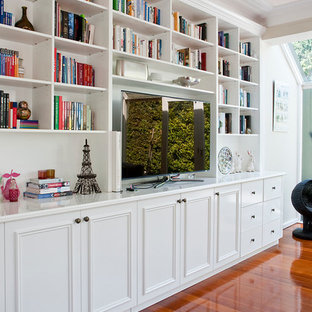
0, 172, 284, 223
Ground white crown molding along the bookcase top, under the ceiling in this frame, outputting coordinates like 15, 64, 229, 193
181, 0, 265, 36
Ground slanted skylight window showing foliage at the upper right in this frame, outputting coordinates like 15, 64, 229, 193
289, 39, 312, 81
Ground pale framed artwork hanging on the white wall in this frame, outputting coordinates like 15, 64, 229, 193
273, 81, 289, 132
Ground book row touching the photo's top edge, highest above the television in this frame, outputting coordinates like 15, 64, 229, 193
113, 0, 161, 25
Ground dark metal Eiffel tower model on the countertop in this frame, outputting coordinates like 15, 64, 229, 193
73, 140, 101, 195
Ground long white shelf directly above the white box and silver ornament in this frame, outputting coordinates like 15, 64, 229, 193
113, 50, 214, 77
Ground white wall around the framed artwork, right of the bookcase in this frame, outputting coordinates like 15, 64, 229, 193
261, 42, 301, 226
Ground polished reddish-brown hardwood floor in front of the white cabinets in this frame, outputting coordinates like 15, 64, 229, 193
144, 224, 312, 312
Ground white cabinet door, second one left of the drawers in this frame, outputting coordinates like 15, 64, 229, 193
181, 190, 213, 283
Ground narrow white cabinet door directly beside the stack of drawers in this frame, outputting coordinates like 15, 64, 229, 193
214, 185, 240, 267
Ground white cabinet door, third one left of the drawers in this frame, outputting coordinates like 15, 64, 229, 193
138, 195, 180, 303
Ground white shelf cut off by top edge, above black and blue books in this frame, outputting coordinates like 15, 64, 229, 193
57, 0, 108, 17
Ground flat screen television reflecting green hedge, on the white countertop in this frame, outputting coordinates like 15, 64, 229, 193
122, 92, 210, 178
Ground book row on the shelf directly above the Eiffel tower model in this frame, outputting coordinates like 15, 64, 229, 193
54, 96, 94, 131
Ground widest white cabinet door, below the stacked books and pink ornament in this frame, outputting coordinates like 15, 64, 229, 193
5, 212, 81, 312
